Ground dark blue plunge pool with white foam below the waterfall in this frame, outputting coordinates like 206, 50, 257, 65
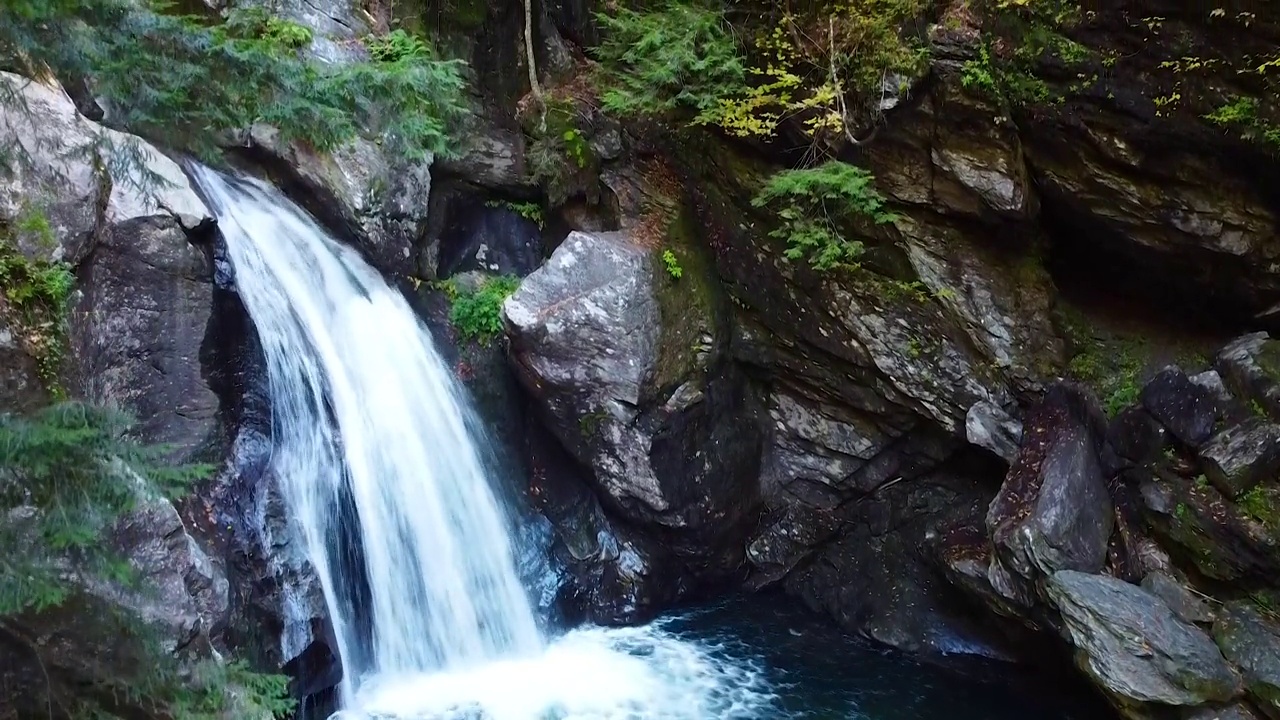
334, 594, 1090, 720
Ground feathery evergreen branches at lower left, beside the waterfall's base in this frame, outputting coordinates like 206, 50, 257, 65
0, 402, 293, 720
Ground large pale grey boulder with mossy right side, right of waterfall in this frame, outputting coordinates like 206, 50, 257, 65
503, 232, 760, 609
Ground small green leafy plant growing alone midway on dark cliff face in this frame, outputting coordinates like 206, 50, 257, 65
751, 160, 897, 270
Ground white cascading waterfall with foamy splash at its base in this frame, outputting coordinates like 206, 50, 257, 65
189, 165, 769, 720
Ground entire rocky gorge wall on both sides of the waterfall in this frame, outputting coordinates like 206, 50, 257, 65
0, 0, 1280, 720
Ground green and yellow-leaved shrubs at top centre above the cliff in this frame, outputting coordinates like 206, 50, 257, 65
598, 0, 929, 142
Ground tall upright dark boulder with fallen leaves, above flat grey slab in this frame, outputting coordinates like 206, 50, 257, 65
987, 383, 1114, 605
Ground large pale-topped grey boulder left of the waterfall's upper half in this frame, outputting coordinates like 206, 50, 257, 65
0, 73, 218, 451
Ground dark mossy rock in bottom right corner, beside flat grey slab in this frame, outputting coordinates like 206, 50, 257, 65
1213, 602, 1280, 719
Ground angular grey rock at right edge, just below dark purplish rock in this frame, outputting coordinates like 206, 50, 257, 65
1199, 418, 1280, 498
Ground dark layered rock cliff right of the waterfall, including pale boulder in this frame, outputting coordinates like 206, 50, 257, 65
494, 1, 1280, 717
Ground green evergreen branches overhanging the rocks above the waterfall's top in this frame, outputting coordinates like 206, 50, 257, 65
0, 0, 463, 158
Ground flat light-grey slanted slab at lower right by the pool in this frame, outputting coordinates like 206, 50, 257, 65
1046, 570, 1239, 717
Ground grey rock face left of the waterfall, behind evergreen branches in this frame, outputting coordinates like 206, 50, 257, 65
0, 73, 332, 712
